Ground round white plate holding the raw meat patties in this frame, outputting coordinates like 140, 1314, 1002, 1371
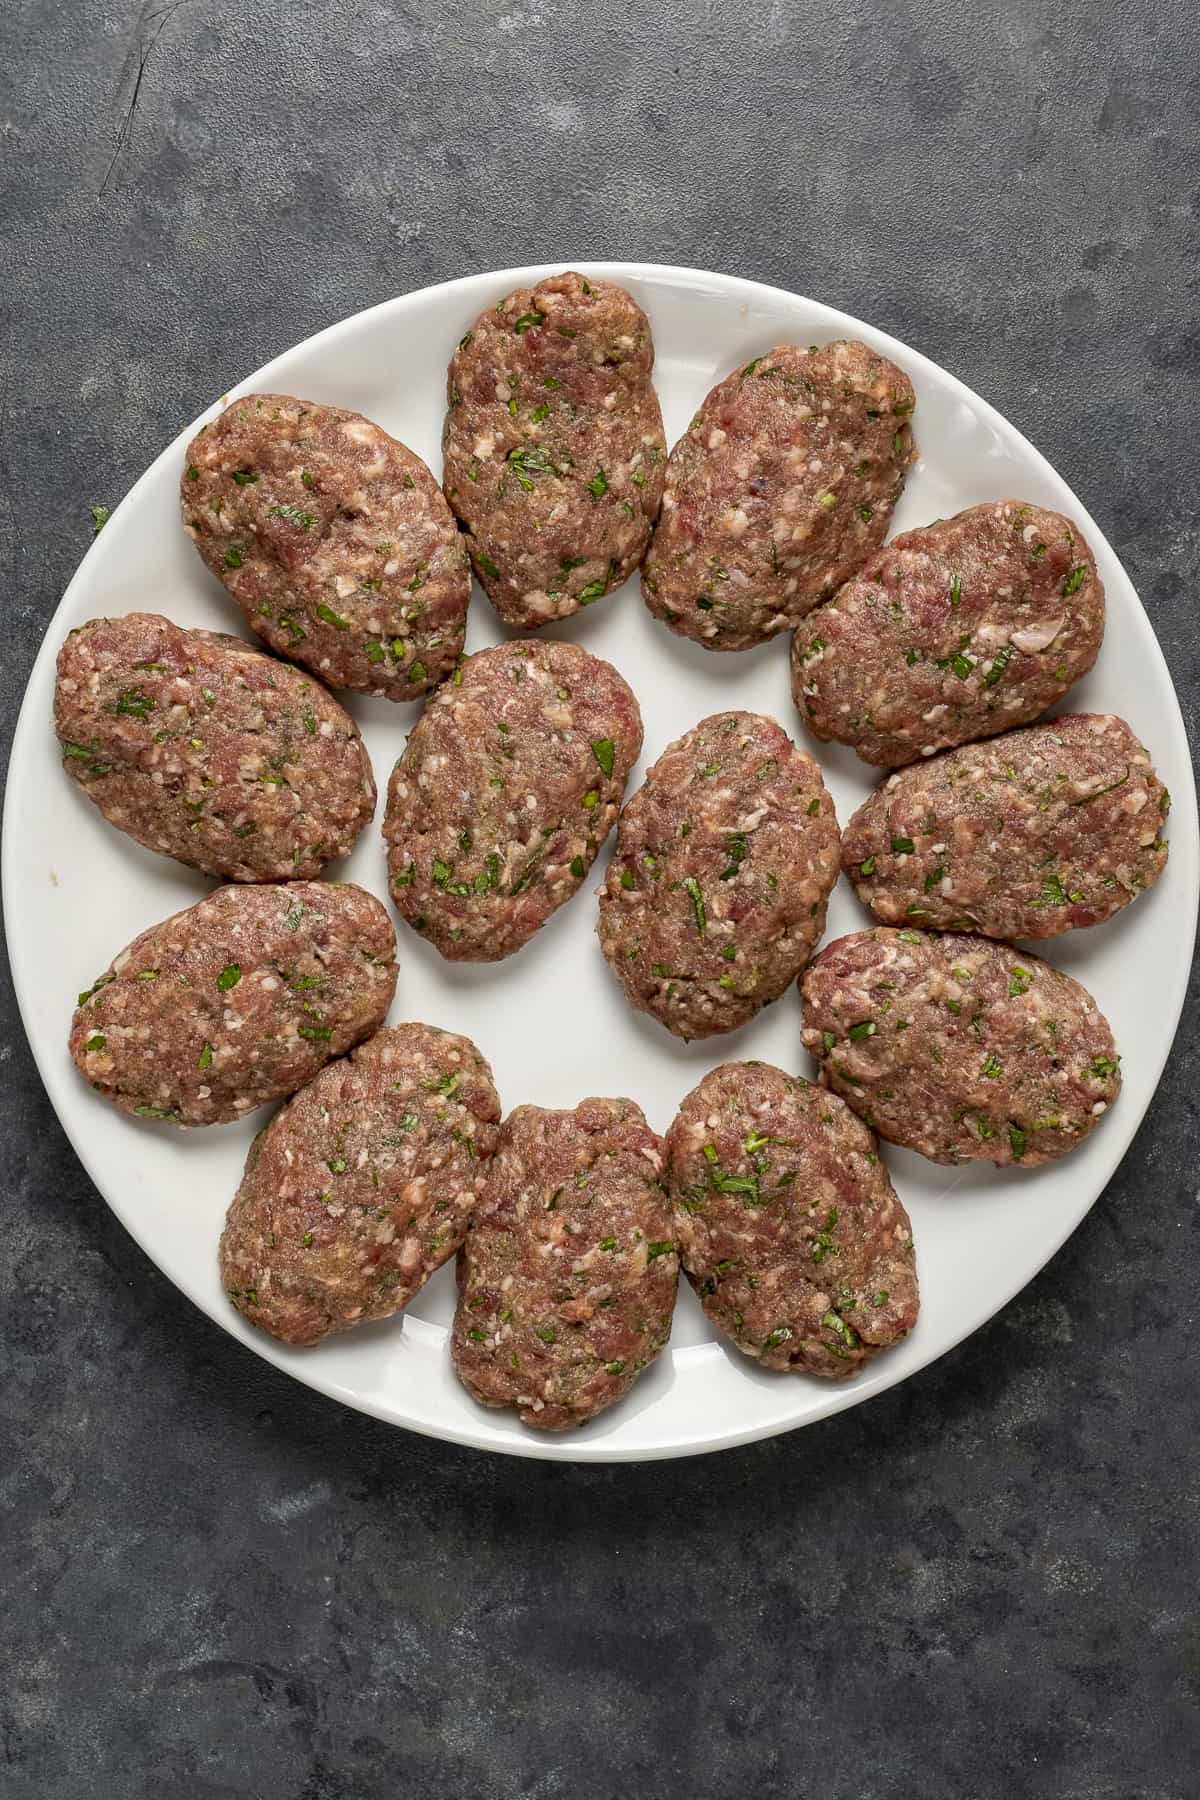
4, 263, 1198, 1462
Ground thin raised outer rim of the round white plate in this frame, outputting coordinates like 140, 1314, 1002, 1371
0, 257, 1200, 1463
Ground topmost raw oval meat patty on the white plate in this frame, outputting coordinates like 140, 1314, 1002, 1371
443, 274, 666, 630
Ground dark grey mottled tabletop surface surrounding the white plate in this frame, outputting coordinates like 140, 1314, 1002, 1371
0, 0, 1200, 1800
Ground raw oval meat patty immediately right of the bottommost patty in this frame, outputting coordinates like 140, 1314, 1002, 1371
666, 1062, 919, 1377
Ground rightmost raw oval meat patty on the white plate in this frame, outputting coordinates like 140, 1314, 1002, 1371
842, 713, 1169, 938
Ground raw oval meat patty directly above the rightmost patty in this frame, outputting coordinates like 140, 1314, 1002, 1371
792, 500, 1105, 769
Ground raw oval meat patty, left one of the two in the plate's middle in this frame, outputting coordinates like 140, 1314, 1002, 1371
383, 639, 642, 961
